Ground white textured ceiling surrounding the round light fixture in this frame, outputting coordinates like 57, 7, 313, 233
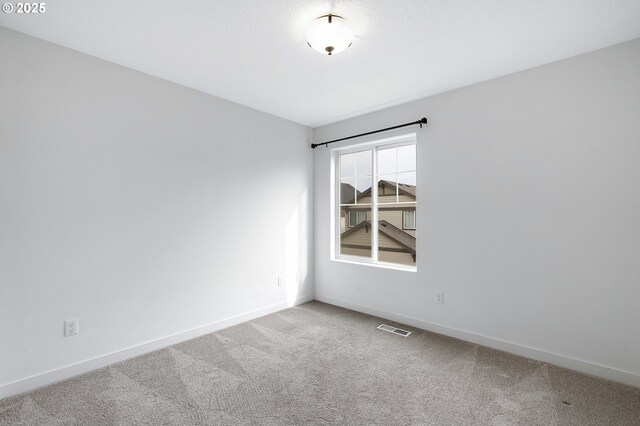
0, 0, 640, 127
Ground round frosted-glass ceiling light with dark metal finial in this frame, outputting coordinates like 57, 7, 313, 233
307, 14, 353, 55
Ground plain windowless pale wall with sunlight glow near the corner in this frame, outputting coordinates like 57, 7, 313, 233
0, 27, 313, 397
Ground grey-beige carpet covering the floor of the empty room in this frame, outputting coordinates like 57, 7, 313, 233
0, 302, 640, 426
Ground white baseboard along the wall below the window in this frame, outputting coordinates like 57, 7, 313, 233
315, 292, 640, 387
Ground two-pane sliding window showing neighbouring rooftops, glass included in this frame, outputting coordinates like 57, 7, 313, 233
333, 135, 416, 268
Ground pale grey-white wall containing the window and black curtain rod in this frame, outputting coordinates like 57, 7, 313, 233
314, 40, 640, 386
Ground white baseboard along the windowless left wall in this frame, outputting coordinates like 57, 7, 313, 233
0, 295, 313, 399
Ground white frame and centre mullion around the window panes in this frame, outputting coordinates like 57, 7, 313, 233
330, 133, 418, 272
